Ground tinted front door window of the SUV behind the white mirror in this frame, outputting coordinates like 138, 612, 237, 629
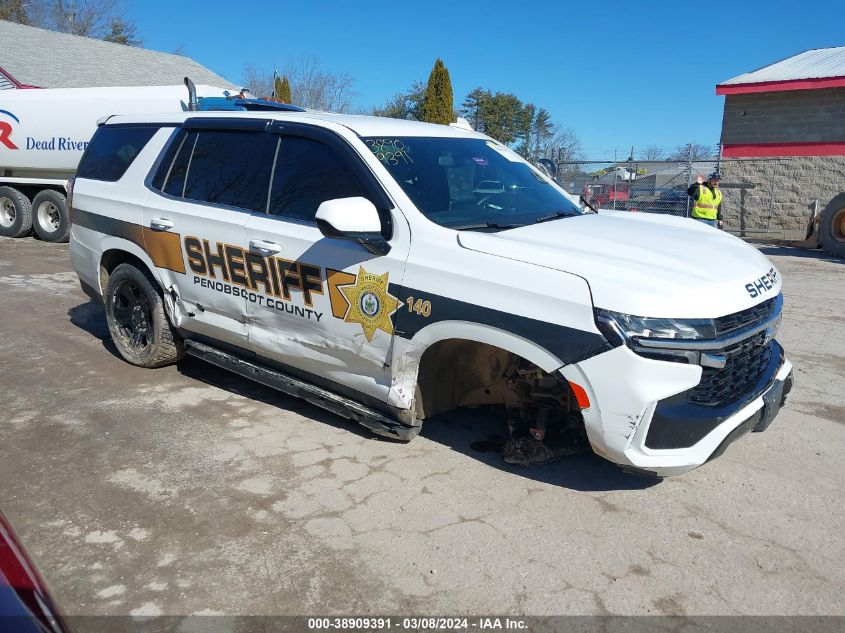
269, 136, 365, 223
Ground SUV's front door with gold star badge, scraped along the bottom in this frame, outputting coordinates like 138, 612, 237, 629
246, 123, 408, 400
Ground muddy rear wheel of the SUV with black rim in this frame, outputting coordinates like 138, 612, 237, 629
105, 264, 185, 368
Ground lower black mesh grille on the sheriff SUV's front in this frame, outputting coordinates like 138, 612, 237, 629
688, 330, 772, 407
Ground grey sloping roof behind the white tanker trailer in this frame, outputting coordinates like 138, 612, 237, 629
0, 20, 238, 90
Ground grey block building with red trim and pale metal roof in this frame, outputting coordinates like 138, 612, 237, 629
716, 46, 845, 238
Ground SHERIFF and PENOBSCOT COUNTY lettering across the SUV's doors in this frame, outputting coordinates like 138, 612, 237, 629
185, 236, 324, 322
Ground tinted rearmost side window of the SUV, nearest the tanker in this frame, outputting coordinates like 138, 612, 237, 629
76, 125, 158, 182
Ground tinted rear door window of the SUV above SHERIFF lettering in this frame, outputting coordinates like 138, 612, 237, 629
182, 130, 279, 213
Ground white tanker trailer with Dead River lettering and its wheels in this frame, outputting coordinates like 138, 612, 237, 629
0, 86, 228, 242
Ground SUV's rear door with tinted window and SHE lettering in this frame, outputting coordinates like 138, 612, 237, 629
144, 118, 278, 347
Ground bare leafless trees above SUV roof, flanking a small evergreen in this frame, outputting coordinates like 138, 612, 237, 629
243, 57, 355, 112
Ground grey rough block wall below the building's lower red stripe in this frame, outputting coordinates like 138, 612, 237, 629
721, 156, 845, 237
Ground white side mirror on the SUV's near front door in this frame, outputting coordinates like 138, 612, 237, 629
315, 197, 390, 255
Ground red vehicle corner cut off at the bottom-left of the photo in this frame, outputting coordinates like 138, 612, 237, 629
0, 512, 69, 633
